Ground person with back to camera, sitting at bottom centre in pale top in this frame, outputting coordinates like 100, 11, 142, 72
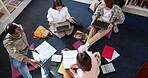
64, 51, 101, 78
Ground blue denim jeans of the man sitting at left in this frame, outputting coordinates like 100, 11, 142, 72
10, 51, 49, 78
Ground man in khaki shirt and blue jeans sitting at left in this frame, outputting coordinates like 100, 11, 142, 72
3, 23, 49, 78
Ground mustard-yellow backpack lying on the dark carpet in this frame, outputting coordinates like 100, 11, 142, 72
32, 25, 52, 39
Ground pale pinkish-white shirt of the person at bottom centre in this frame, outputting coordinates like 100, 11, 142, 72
77, 52, 100, 78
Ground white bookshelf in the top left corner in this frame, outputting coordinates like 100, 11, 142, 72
0, 0, 31, 34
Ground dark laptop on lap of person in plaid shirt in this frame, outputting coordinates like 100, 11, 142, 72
92, 19, 109, 30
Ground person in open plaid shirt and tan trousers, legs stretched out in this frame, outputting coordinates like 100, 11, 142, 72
78, 0, 125, 51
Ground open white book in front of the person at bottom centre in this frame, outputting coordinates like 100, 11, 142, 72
63, 50, 78, 69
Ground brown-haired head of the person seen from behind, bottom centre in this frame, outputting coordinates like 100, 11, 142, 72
76, 51, 92, 71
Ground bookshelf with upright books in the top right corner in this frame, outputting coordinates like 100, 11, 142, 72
122, 0, 148, 17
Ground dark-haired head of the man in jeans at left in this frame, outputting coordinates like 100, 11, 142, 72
5, 23, 23, 37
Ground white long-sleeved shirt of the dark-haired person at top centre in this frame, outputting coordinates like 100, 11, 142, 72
47, 7, 70, 23
